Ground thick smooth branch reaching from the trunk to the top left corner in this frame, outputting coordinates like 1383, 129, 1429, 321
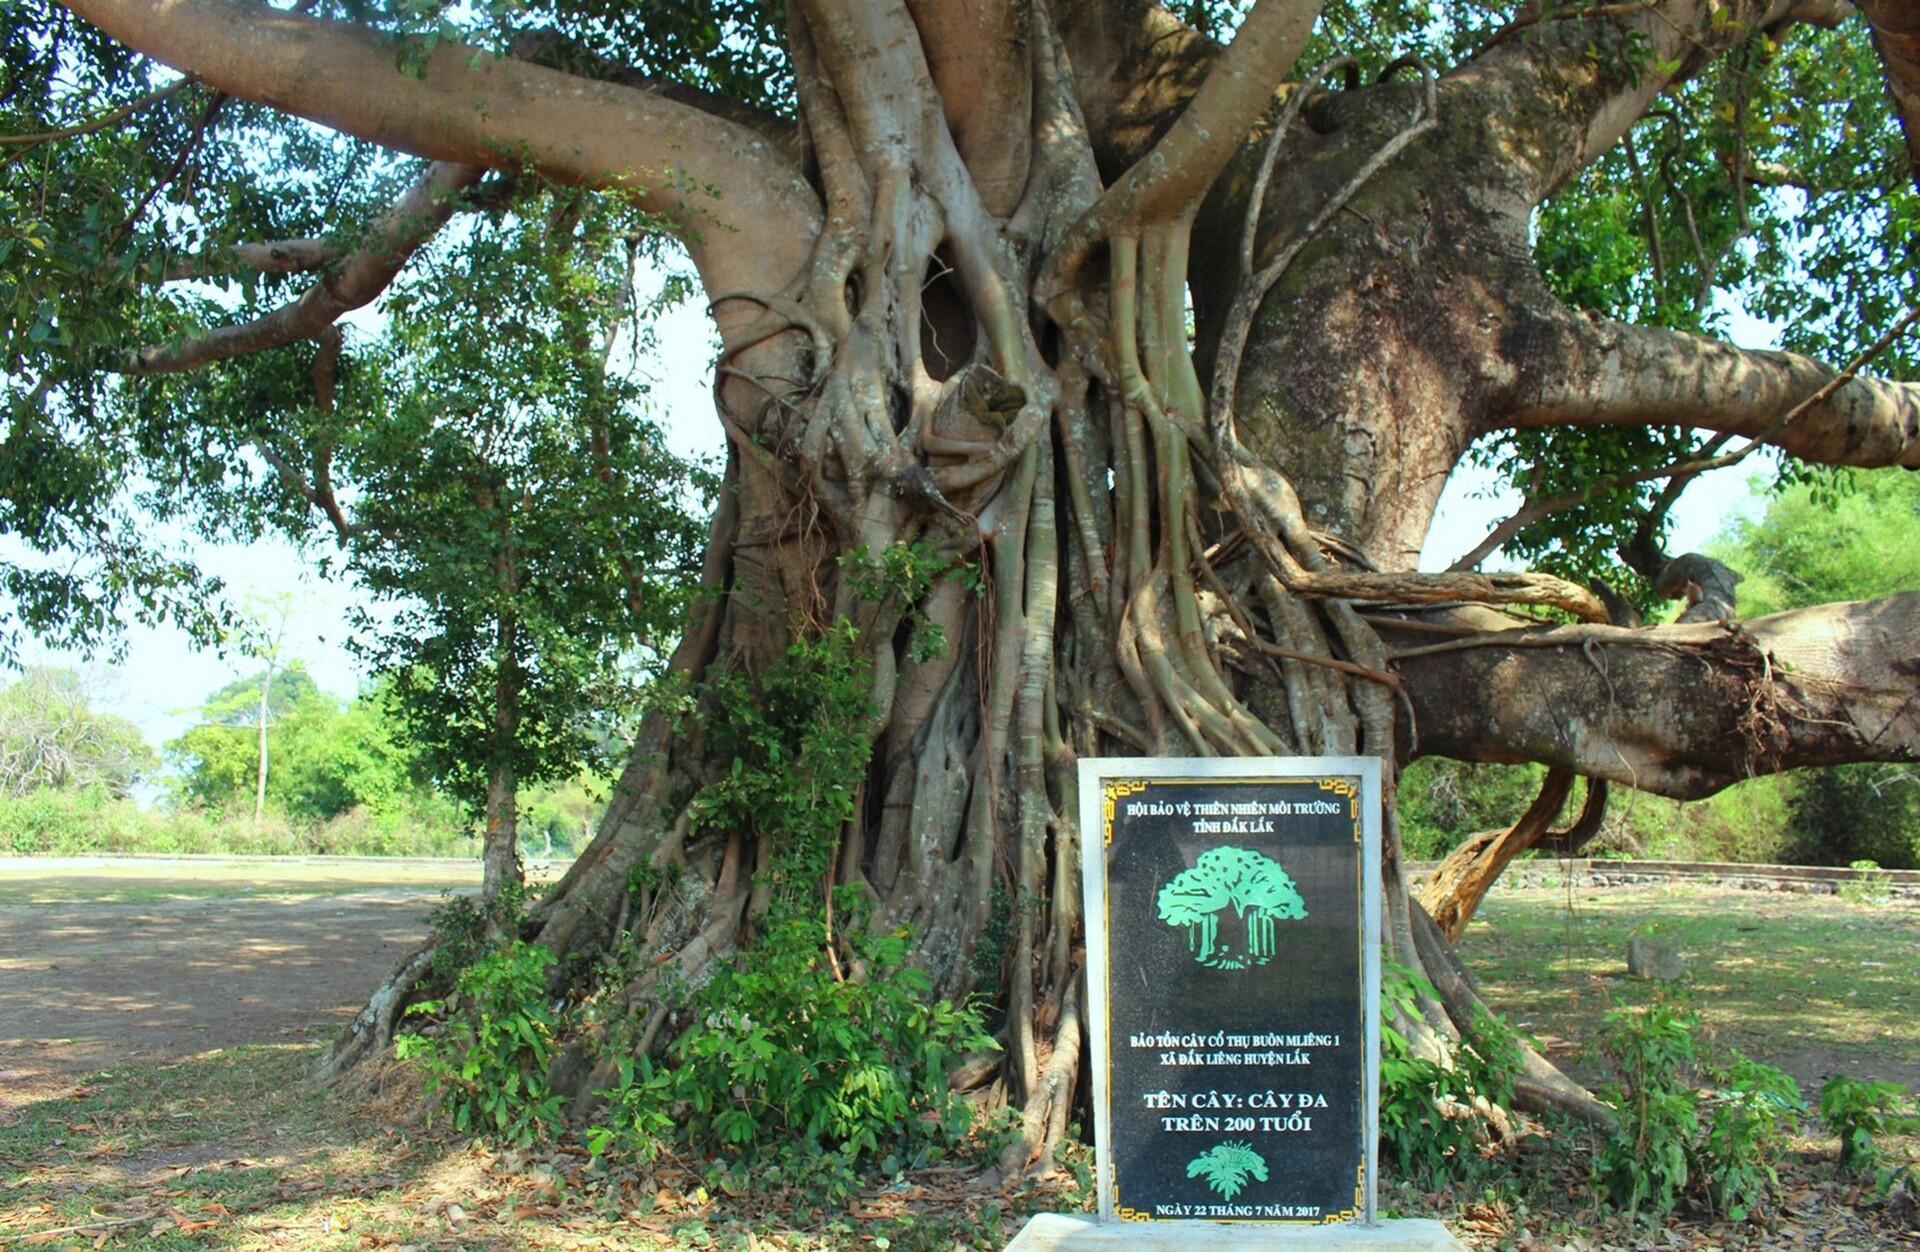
56, 0, 820, 290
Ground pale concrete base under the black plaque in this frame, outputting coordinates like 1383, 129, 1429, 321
1006, 1214, 1467, 1252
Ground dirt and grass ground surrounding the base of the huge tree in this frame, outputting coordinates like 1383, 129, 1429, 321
0, 858, 1920, 1252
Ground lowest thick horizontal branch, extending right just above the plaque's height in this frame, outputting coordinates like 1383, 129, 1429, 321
1397, 591, 1920, 799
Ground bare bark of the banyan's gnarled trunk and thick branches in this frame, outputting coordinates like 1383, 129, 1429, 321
69, 0, 1920, 1166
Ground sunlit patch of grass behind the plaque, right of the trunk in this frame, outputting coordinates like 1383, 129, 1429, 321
1461, 885, 1920, 1091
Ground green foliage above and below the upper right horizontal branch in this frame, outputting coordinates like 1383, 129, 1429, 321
1473, 12, 1916, 587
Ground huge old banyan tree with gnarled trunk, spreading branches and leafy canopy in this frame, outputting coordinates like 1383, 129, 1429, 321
0, 0, 1920, 1166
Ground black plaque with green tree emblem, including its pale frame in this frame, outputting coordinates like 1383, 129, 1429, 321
1079, 757, 1380, 1223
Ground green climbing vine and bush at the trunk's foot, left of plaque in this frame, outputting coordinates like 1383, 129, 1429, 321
591, 624, 993, 1169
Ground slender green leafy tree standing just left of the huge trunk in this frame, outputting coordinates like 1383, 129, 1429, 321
330, 194, 712, 899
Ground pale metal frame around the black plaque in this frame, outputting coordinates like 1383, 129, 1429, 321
1079, 757, 1380, 1225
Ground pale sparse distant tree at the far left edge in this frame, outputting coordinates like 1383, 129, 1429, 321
0, 666, 159, 795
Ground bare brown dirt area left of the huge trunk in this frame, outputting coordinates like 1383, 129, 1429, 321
0, 858, 478, 1125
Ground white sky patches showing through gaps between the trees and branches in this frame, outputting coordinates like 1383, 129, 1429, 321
15, 288, 1776, 745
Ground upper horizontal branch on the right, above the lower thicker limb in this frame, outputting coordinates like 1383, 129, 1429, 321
1488, 315, 1920, 469
